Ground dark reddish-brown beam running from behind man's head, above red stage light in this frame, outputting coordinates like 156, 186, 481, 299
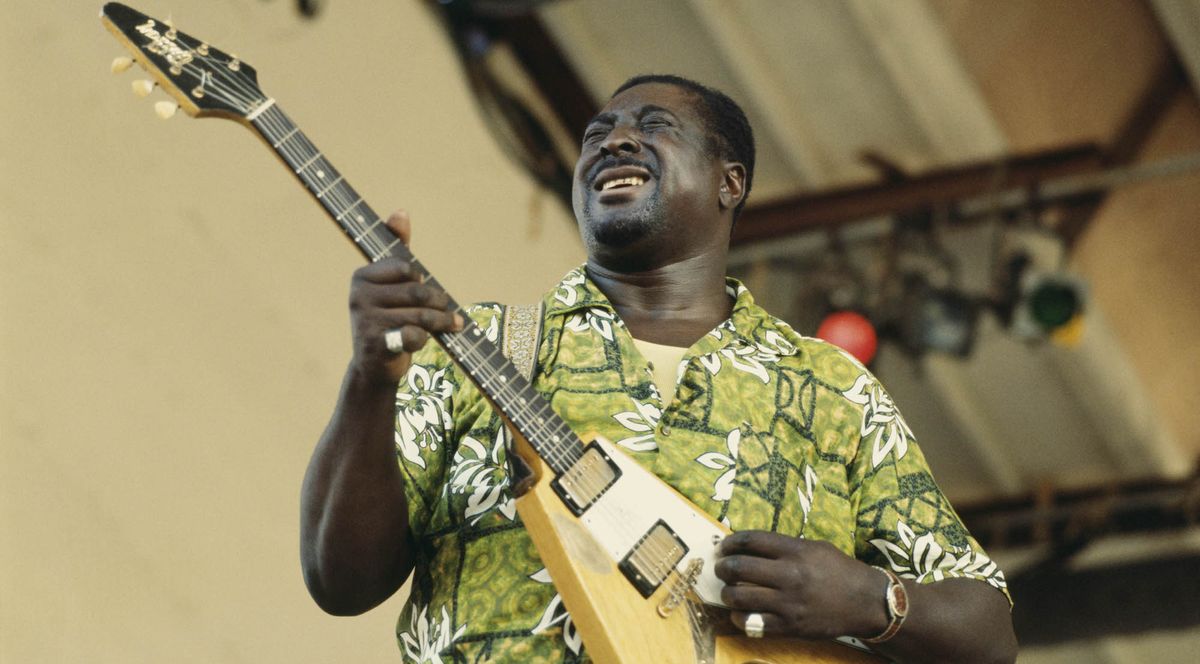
733, 143, 1104, 245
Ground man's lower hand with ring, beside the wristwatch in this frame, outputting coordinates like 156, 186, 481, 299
714, 531, 888, 639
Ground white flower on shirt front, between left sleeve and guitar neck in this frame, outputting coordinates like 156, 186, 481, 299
446, 426, 517, 526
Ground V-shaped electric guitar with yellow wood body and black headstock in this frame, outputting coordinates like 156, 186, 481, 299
101, 2, 880, 664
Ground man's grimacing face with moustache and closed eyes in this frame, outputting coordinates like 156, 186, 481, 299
572, 83, 728, 262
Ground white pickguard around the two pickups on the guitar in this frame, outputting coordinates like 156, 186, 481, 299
580, 437, 725, 606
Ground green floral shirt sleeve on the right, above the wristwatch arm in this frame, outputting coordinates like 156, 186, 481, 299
842, 358, 1012, 602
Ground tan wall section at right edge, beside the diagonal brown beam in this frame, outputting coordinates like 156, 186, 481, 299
1074, 92, 1200, 459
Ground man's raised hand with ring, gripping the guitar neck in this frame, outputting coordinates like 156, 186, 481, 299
350, 210, 463, 384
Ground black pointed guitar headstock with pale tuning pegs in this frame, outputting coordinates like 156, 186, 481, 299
100, 2, 268, 121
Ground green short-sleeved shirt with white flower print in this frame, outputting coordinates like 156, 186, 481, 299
396, 268, 1007, 663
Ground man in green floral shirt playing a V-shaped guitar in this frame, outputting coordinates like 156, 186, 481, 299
301, 77, 1016, 663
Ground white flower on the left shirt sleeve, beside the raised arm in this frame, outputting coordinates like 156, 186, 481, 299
396, 364, 454, 468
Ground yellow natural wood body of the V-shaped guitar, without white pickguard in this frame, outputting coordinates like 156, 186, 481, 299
516, 429, 883, 664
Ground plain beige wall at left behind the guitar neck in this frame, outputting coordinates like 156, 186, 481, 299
0, 0, 582, 663
